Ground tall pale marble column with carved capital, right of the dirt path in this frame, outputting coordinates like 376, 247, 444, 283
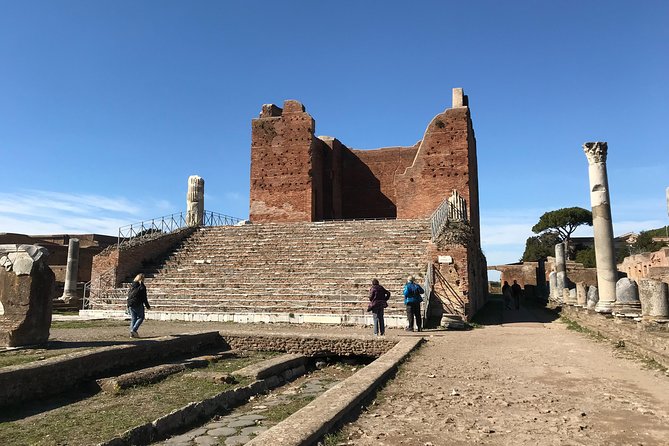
583, 142, 618, 313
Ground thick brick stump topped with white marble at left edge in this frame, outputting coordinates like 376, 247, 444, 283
0, 245, 55, 347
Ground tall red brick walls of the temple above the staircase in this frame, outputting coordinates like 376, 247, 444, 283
250, 101, 480, 230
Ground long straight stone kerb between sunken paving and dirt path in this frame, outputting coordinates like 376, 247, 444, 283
246, 338, 423, 446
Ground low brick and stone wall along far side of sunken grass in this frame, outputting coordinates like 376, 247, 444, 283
0, 331, 396, 406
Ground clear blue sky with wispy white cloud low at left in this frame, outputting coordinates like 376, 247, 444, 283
0, 0, 669, 265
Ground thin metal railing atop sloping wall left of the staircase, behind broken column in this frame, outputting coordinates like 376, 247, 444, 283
118, 211, 242, 247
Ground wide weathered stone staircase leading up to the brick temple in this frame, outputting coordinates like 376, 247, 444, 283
85, 220, 430, 326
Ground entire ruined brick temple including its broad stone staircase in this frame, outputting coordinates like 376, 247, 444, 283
84, 89, 487, 327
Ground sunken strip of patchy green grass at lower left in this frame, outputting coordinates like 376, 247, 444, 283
0, 353, 268, 446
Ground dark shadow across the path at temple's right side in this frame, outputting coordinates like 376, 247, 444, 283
473, 294, 559, 325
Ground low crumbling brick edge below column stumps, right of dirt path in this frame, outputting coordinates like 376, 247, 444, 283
555, 306, 669, 368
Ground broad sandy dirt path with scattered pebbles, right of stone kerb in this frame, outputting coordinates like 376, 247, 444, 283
343, 307, 669, 446
